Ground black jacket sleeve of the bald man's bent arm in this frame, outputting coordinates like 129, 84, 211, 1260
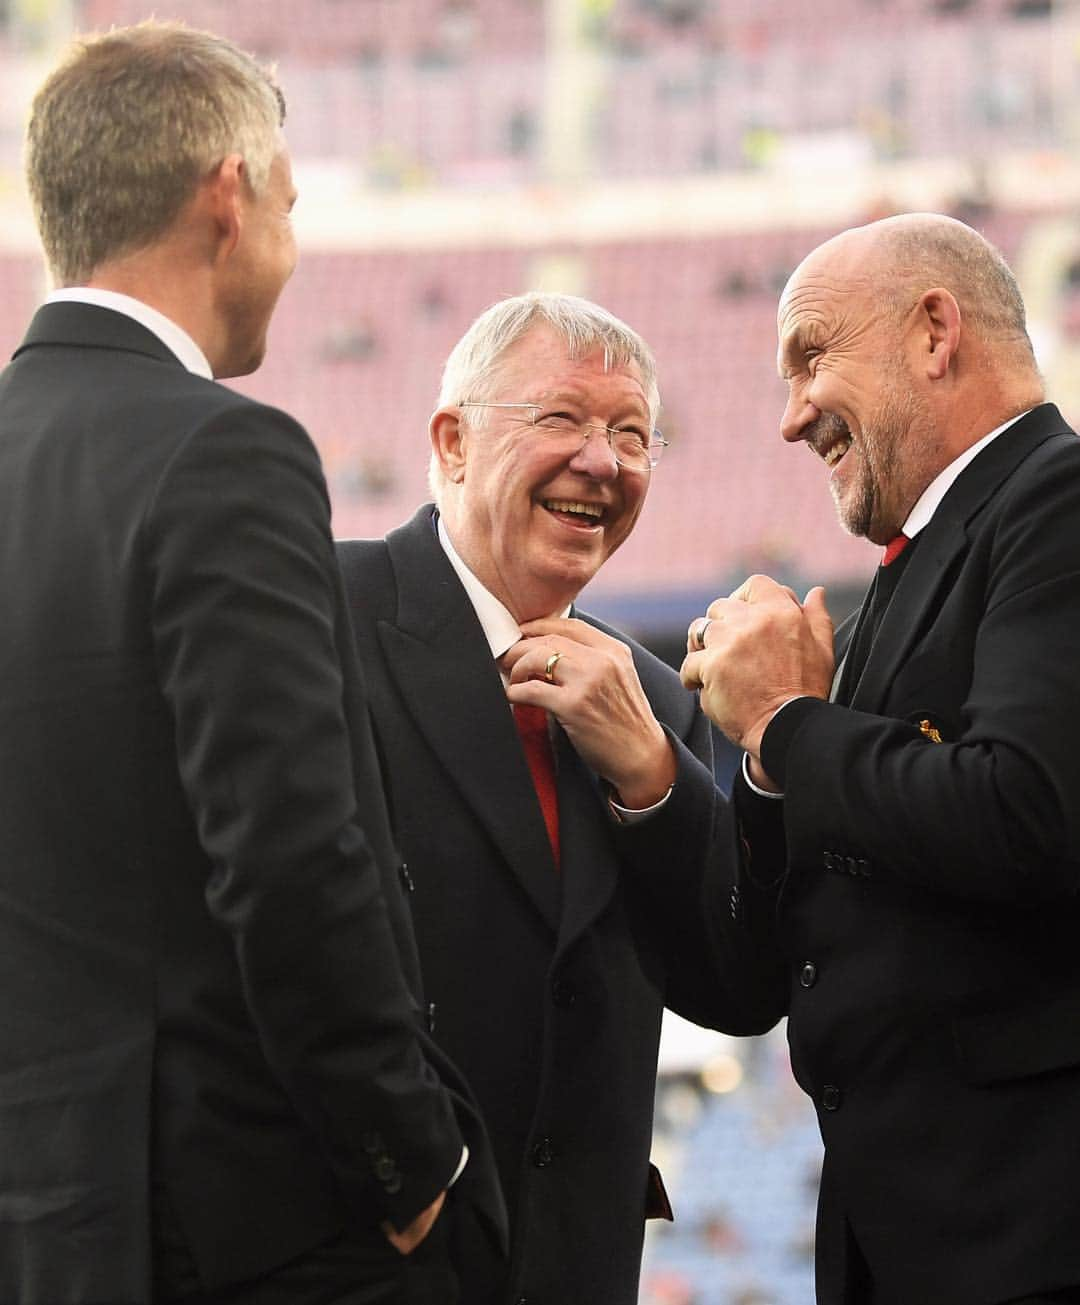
763, 438, 1080, 902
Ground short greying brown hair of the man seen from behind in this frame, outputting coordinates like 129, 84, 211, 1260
26, 22, 284, 286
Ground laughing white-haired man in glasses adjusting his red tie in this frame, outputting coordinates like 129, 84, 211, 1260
339, 294, 771, 1305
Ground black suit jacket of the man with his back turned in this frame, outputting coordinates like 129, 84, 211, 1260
0, 304, 506, 1305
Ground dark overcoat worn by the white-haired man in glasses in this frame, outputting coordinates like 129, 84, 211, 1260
338, 506, 770, 1305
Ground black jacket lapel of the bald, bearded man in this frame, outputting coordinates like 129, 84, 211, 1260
850, 403, 1071, 713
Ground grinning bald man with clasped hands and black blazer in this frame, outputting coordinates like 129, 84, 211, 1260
683, 214, 1080, 1305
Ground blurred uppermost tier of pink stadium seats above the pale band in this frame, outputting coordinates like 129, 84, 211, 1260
59, 0, 1068, 187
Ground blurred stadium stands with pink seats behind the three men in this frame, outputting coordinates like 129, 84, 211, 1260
0, 0, 1080, 1305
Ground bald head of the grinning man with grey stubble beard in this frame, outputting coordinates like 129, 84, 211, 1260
777, 213, 1042, 543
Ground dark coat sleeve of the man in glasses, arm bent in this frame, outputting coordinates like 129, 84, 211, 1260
616, 681, 788, 1035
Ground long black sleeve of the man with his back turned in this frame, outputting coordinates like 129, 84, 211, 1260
143, 405, 462, 1227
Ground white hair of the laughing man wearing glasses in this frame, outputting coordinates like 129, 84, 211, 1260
428, 290, 660, 500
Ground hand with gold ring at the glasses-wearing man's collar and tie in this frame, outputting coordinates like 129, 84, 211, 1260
502, 619, 676, 810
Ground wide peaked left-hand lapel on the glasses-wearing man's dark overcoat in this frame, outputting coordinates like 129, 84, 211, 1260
378, 508, 562, 930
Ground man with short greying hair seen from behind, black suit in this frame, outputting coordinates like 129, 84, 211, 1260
0, 23, 505, 1305
